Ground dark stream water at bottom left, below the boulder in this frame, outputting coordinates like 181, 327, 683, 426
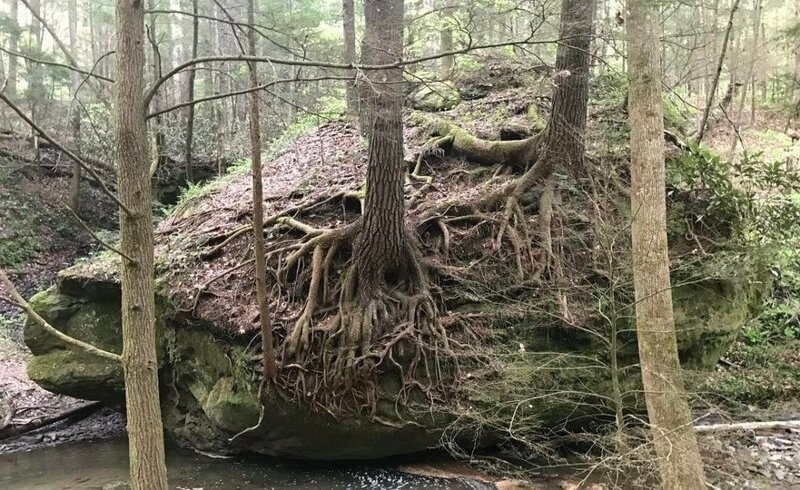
0, 439, 491, 490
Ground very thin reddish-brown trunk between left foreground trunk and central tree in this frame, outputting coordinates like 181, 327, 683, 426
247, 0, 277, 381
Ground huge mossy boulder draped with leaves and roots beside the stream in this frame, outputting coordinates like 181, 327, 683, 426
20, 88, 765, 459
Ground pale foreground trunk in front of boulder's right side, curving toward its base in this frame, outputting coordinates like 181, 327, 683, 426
626, 0, 705, 490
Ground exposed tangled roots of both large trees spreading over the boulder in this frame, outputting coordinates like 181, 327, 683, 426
183, 120, 580, 417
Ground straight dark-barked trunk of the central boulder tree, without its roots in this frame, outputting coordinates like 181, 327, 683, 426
355, 0, 407, 291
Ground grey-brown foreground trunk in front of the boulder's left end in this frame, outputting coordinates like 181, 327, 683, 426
114, 0, 167, 490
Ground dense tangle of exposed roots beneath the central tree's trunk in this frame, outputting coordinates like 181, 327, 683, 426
279, 212, 449, 400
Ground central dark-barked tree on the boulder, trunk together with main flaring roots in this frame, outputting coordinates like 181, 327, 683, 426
287, 0, 446, 372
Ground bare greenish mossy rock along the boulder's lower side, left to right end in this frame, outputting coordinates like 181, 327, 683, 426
25, 261, 759, 460
